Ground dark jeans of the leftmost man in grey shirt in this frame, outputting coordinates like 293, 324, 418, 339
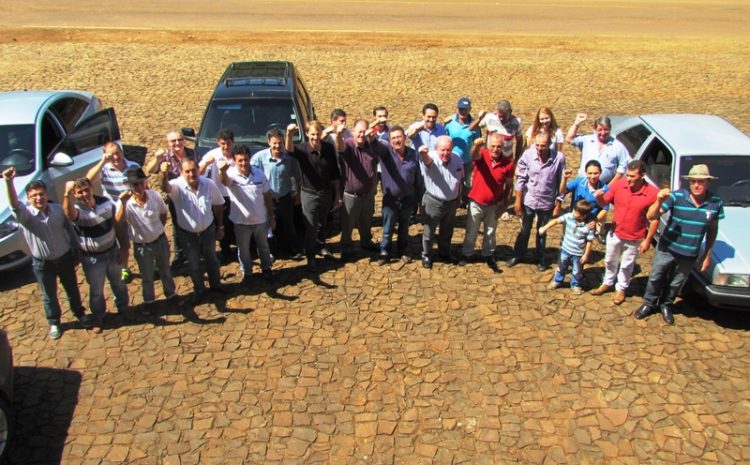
31, 251, 84, 325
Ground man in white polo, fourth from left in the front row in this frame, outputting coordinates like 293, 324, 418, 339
161, 158, 226, 303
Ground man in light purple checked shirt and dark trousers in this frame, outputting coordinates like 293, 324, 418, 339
508, 133, 565, 271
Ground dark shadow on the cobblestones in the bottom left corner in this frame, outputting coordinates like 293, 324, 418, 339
8, 367, 81, 464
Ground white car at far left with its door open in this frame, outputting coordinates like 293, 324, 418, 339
0, 91, 120, 271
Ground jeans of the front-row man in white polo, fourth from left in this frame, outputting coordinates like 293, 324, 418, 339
177, 224, 221, 292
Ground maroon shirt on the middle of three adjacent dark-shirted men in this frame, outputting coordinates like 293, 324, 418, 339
339, 139, 384, 196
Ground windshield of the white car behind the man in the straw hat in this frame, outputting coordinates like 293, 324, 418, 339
680, 155, 750, 206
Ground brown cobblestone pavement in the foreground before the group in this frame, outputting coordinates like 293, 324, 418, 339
0, 211, 750, 465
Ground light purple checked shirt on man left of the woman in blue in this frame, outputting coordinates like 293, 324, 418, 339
515, 145, 565, 210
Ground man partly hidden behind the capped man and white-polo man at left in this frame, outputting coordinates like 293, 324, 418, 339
145, 129, 196, 272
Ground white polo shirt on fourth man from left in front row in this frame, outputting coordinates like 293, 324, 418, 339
168, 176, 224, 233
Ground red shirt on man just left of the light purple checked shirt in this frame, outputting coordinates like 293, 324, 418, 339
469, 149, 516, 206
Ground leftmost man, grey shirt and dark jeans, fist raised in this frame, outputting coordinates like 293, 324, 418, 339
3, 167, 91, 339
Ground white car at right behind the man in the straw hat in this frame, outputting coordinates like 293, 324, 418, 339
612, 114, 750, 310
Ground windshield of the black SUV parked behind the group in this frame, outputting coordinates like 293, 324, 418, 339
198, 98, 301, 145
